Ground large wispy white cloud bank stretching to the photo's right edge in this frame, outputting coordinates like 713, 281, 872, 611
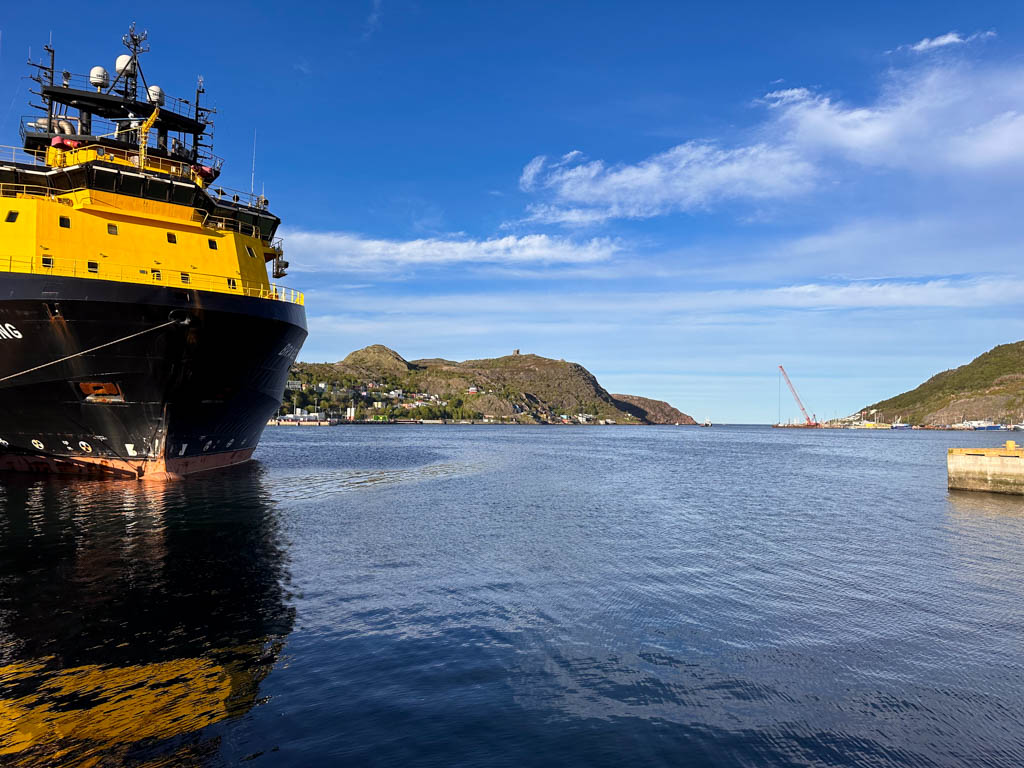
520, 57, 1024, 226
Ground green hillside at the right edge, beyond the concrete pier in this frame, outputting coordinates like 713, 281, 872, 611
864, 341, 1024, 425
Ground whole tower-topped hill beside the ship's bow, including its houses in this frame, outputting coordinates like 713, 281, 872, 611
285, 344, 693, 424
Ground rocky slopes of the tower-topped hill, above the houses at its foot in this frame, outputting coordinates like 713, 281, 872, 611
295, 344, 694, 424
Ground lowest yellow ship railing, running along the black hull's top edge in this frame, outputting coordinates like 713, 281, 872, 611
0, 252, 305, 305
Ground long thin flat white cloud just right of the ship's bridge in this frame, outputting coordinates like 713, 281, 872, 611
283, 230, 621, 272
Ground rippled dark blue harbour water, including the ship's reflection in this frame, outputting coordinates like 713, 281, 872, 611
0, 426, 1024, 767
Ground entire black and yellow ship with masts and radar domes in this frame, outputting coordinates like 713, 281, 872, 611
0, 25, 307, 480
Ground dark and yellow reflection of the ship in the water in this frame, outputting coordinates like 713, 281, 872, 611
0, 466, 294, 766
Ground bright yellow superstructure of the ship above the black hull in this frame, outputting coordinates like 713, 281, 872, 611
0, 146, 303, 304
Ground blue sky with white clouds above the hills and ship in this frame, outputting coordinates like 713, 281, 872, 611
0, 0, 1024, 422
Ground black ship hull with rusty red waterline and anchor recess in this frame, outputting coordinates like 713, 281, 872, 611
0, 273, 306, 479
